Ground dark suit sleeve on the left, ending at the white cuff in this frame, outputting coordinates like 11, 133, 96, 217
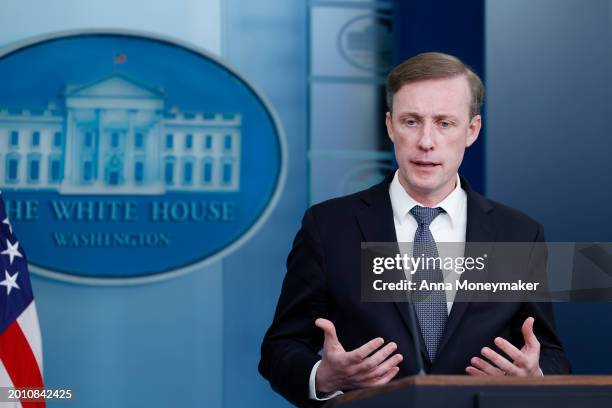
259, 209, 328, 406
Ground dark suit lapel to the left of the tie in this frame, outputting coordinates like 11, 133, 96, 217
357, 172, 431, 364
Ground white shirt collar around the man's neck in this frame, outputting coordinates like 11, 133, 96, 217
389, 170, 465, 230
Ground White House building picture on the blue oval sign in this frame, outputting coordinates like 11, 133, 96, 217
0, 73, 242, 194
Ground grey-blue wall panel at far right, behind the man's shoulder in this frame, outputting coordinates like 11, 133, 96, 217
486, 0, 612, 374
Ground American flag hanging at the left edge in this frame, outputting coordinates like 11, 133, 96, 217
0, 197, 45, 408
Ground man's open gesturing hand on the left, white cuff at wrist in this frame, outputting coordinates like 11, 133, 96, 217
315, 319, 403, 393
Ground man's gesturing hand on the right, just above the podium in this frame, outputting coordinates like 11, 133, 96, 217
465, 317, 542, 376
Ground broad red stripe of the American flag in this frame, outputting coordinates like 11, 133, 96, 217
0, 321, 45, 408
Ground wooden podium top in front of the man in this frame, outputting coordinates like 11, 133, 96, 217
324, 375, 612, 408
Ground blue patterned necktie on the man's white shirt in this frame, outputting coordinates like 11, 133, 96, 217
410, 205, 448, 363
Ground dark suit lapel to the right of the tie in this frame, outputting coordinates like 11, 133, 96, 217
438, 177, 495, 355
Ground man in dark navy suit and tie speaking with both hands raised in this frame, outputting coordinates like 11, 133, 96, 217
259, 53, 570, 406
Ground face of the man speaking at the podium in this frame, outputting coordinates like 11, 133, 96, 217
386, 75, 481, 204
